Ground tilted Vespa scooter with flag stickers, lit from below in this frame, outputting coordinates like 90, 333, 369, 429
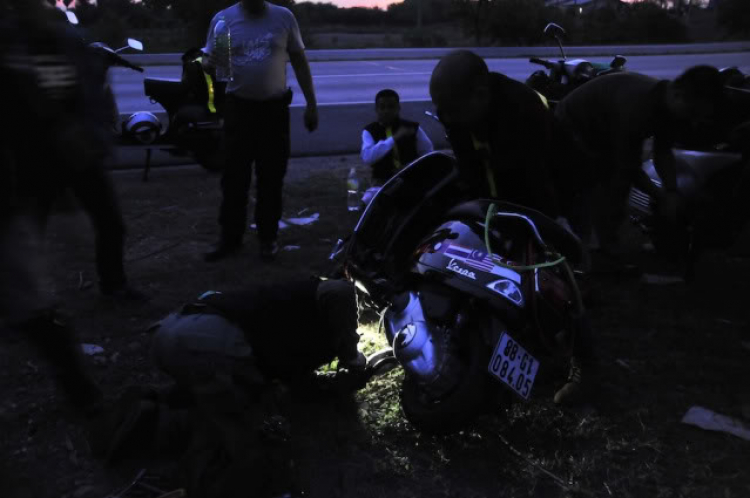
332, 152, 582, 433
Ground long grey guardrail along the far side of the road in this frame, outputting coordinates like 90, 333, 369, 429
127, 42, 750, 66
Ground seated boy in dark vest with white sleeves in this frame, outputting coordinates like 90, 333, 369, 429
360, 88, 434, 204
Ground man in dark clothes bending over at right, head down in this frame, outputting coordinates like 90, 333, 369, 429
555, 66, 723, 252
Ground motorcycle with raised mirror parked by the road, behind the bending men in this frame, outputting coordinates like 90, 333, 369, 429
526, 23, 627, 104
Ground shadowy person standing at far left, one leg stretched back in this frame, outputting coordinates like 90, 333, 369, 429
2, 1, 146, 300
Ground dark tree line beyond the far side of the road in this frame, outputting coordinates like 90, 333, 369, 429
67, 0, 750, 50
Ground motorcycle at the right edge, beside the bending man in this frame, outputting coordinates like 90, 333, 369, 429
629, 76, 750, 280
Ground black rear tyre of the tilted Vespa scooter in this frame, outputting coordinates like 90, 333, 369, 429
400, 324, 492, 434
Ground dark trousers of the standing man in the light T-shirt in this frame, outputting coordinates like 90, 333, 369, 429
219, 94, 290, 245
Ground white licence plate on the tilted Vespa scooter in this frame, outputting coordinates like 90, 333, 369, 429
489, 333, 539, 399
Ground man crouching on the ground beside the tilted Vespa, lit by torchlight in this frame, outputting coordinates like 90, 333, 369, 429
92, 278, 366, 486
